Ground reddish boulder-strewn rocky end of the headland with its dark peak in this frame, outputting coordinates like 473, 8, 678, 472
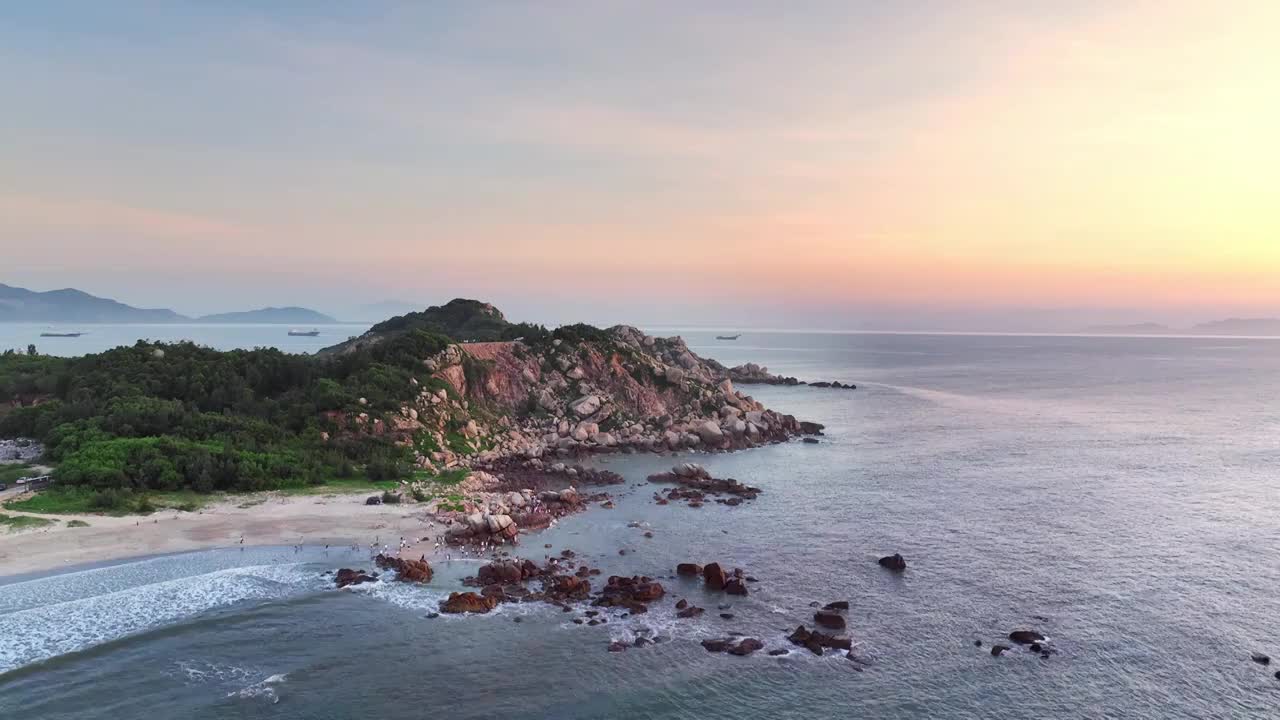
317, 301, 829, 471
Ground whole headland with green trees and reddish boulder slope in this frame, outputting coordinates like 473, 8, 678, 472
0, 300, 815, 507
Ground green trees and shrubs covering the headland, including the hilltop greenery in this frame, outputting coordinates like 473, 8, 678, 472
0, 300, 619, 514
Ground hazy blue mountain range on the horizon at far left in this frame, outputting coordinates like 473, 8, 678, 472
0, 283, 338, 325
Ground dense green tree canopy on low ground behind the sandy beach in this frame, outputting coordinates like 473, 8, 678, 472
0, 329, 451, 492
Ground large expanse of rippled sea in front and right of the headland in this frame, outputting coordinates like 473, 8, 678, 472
0, 333, 1280, 720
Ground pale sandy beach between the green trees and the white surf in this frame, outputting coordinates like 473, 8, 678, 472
0, 492, 443, 577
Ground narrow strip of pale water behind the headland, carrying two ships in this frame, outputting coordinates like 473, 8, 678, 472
0, 323, 369, 357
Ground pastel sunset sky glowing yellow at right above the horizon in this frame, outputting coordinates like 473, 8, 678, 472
0, 0, 1280, 329
